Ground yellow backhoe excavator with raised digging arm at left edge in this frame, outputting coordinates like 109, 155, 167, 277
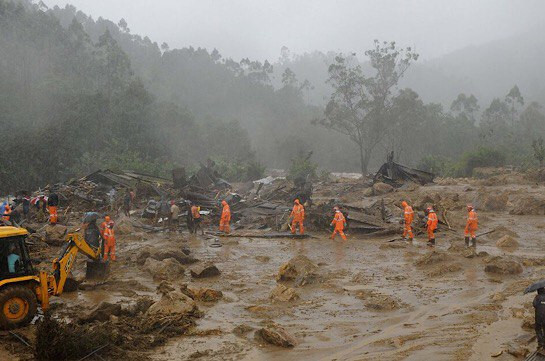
0, 226, 108, 329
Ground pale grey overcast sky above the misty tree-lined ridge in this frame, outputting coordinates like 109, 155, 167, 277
43, 0, 545, 60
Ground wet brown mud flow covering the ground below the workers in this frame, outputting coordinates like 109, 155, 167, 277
0, 174, 545, 360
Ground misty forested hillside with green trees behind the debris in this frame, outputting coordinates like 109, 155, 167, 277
0, 0, 545, 192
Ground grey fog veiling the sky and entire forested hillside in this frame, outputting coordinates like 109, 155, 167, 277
0, 0, 545, 192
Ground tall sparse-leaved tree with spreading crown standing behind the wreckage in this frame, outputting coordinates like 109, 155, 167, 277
314, 40, 418, 175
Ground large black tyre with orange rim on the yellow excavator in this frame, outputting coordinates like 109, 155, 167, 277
0, 286, 37, 330
